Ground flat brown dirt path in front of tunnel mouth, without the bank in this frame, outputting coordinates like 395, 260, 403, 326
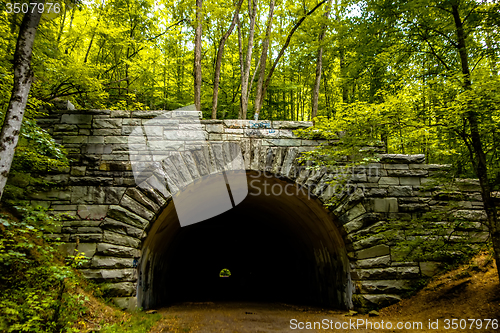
150, 302, 436, 333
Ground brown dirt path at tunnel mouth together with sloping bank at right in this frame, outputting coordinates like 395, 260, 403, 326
150, 254, 500, 333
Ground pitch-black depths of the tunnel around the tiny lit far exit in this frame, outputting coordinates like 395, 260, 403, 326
160, 207, 314, 301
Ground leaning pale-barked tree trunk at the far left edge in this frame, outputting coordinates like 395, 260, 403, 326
0, 0, 45, 198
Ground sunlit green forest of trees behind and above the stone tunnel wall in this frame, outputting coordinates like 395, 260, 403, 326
0, 0, 500, 330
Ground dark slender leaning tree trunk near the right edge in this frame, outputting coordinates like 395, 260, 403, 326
451, 3, 500, 279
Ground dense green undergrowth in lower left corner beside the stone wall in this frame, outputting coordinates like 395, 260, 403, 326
0, 207, 90, 332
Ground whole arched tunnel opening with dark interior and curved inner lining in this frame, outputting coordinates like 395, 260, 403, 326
137, 171, 352, 309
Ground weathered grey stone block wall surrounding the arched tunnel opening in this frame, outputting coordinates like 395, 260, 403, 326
28, 110, 487, 308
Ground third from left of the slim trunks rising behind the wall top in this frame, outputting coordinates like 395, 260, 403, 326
238, 0, 257, 119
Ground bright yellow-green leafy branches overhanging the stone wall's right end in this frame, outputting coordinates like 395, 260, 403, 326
295, 72, 500, 179
